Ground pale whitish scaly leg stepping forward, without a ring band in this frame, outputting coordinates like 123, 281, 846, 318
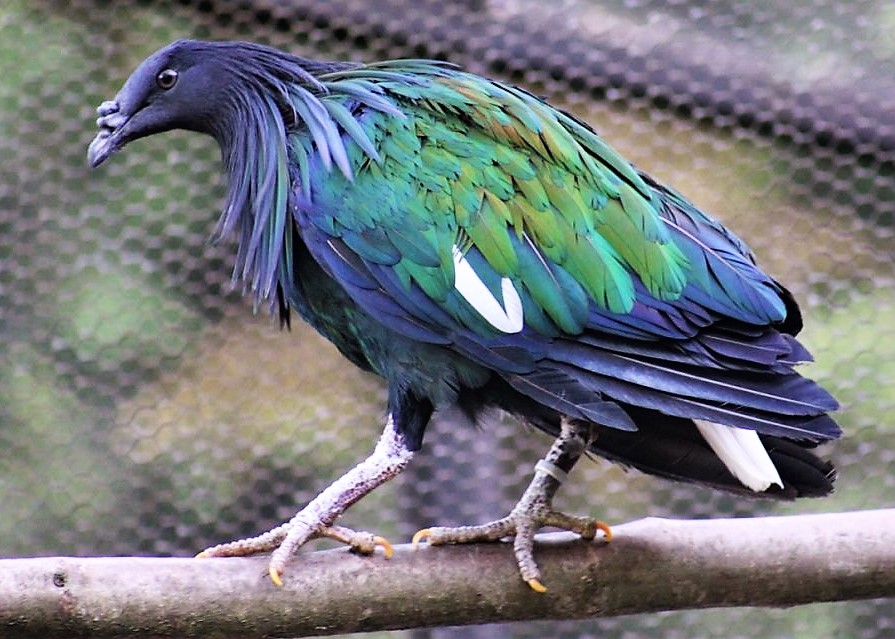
199, 415, 413, 585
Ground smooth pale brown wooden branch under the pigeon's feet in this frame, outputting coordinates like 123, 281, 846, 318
0, 509, 895, 639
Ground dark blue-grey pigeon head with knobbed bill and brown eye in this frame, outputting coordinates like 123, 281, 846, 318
88, 40, 339, 167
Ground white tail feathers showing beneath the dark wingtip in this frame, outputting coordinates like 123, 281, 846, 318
693, 419, 783, 493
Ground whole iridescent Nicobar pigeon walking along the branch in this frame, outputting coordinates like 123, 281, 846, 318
88, 40, 840, 591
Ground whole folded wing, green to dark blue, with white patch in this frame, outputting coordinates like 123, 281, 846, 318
292, 62, 835, 437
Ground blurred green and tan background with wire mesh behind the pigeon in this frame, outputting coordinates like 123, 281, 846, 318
0, 0, 895, 639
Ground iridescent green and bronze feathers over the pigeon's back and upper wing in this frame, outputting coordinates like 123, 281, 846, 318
297, 61, 688, 332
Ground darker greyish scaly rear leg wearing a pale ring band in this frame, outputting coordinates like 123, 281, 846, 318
413, 420, 612, 592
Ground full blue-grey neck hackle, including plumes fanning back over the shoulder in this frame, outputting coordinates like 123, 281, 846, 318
201, 45, 418, 311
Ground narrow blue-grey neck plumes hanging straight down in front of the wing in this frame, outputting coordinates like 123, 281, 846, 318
208, 43, 352, 310
